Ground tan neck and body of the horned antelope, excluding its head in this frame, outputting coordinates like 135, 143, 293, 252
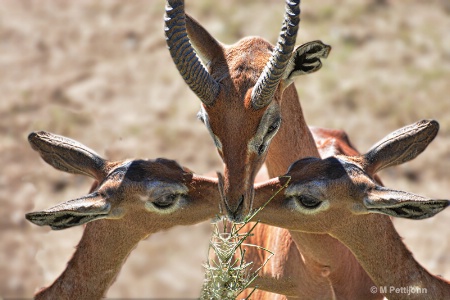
237, 102, 382, 299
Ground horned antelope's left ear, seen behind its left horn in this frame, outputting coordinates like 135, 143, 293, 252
186, 14, 223, 66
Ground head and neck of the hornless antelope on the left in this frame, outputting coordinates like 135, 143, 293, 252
27, 132, 219, 299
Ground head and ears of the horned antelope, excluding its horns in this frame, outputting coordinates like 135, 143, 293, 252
176, 7, 331, 221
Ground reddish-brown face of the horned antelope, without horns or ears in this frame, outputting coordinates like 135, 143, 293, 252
198, 38, 281, 221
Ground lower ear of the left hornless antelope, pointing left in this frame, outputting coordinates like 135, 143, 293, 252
25, 192, 111, 230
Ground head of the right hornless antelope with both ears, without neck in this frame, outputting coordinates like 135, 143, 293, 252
255, 120, 450, 235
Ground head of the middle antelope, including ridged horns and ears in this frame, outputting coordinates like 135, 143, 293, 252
165, 0, 331, 221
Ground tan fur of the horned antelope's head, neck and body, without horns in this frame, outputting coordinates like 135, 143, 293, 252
172, 4, 382, 299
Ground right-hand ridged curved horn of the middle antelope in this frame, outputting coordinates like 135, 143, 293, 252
252, 0, 300, 109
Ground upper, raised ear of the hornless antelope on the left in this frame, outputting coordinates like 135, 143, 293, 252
28, 131, 107, 181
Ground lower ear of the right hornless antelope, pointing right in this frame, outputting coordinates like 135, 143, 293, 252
364, 187, 450, 220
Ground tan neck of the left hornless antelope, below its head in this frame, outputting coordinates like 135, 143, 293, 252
35, 220, 148, 299
